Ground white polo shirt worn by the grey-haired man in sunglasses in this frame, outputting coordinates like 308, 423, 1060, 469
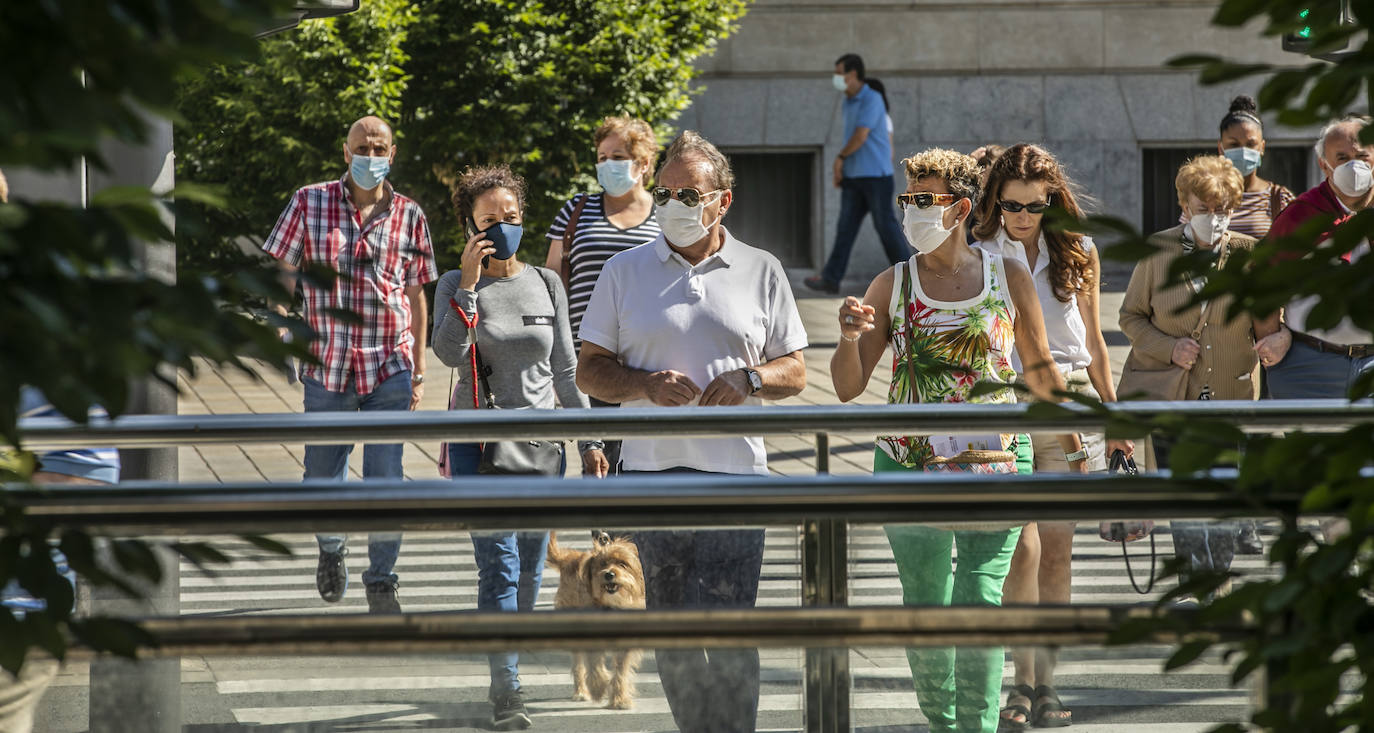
578, 230, 807, 474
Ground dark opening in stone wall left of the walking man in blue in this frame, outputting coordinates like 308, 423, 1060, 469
725, 150, 819, 267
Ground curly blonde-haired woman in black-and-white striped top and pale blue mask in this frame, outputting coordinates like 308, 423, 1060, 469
544, 117, 661, 473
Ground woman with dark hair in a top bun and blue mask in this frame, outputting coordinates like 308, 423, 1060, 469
1209, 95, 1293, 239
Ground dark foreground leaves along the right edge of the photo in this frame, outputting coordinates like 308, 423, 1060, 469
1079, 0, 1374, 732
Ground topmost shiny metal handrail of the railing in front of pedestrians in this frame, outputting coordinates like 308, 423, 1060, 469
19, 400, 1374, 450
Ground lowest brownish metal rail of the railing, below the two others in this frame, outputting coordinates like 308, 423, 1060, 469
75, 605, 1254, 657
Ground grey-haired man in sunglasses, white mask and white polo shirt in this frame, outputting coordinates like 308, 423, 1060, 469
577, 131, 807, 732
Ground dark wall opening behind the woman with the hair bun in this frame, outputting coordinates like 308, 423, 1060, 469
1140, 144, 1312, 232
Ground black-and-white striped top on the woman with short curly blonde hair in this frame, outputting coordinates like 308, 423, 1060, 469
548, 194, 662, 351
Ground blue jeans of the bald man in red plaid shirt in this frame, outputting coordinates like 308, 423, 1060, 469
310, 370, 411, 584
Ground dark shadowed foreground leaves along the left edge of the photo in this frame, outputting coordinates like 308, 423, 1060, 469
0, 0, 305, 670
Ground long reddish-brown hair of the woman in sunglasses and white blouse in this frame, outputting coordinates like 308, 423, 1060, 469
973, 143, 1096, 303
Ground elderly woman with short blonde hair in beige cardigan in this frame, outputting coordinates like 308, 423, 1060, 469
1117, 155, 1278, 588
